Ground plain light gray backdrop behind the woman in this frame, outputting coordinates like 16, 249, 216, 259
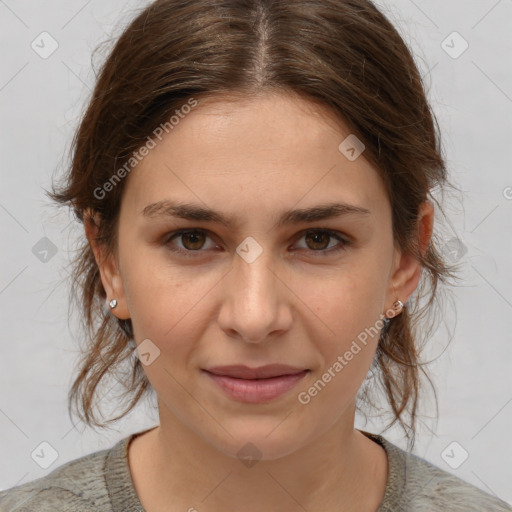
0, 0, 512, 504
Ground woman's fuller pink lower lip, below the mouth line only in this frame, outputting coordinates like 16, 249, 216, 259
204, 370, 309, 404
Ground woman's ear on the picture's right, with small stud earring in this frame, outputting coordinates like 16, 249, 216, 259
386, 201, 434, 310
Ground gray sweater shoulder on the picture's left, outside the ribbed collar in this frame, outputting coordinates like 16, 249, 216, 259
0, 441, 114, 512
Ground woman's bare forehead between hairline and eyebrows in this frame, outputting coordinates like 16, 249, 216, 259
117, 94, 387, 226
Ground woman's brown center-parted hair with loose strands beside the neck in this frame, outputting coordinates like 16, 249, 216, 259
48, 0, 455, 448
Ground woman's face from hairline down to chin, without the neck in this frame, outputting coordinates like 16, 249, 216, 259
87, 91, 428, 459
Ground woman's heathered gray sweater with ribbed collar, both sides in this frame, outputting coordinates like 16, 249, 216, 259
0, 431, 512, 512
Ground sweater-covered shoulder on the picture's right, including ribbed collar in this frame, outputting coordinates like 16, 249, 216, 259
360, 433, 512, 512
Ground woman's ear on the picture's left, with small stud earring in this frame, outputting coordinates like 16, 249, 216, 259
84, 210, 130, 320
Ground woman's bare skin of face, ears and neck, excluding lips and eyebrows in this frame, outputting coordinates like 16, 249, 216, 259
86, 90, 434, 512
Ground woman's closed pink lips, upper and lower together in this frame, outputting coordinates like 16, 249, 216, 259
203, 365, 309, 404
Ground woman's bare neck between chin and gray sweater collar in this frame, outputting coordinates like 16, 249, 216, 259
129, 407, 387, 512
